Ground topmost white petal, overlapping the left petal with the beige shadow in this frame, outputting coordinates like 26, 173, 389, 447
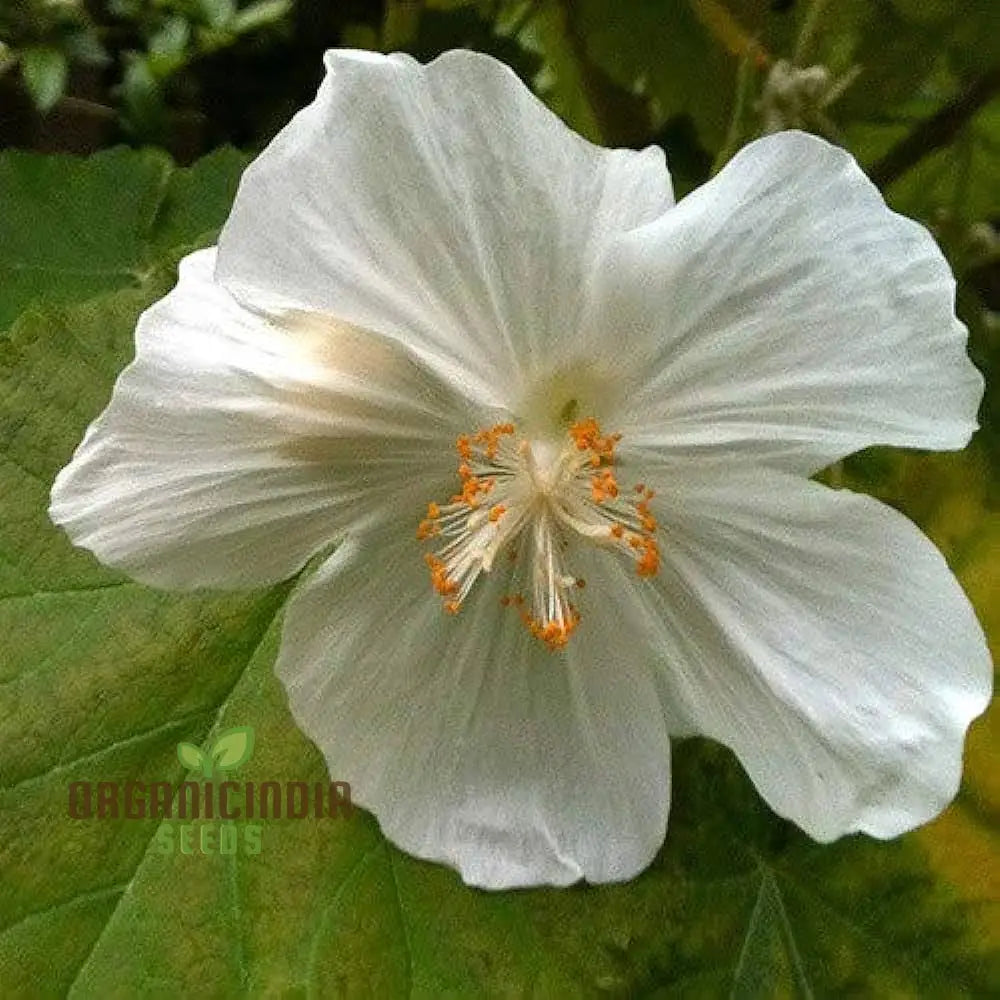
219, 51, 672, 407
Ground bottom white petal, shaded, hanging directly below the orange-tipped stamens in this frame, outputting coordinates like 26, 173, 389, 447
277, 530, 669, 889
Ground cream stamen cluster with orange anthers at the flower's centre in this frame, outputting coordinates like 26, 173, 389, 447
417, 417, 660, 650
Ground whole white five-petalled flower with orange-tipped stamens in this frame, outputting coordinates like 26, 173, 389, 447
51, 52, 991, 888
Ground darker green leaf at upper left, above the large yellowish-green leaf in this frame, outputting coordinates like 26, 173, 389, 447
0, 149, 246, 331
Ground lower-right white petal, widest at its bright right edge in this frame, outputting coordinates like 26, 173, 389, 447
632, 470, 992, 841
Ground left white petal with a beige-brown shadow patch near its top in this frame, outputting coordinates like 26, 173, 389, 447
50, 250, 468, 587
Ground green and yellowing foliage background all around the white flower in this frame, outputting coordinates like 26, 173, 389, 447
0, 0, 1000, 1000
